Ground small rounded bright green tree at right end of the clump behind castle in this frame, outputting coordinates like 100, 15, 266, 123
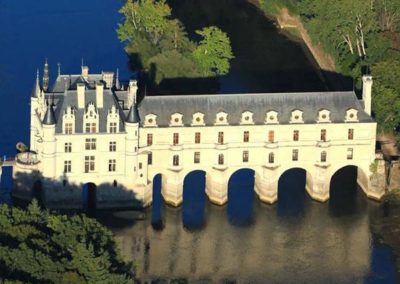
193, 26, 234, 76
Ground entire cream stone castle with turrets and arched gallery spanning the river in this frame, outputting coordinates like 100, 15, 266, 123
14, 64, 383, 207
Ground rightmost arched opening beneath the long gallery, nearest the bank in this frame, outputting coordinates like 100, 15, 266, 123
329, 165, 368, 217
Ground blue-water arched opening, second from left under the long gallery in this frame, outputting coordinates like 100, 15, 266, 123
182, 170, 207, 229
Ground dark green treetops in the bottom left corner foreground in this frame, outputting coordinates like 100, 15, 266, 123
0, 201, 133, 283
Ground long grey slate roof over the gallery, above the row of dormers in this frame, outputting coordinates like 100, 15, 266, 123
139, 92, 373, 126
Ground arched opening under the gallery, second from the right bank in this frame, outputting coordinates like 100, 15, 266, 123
277, 168, 312, 216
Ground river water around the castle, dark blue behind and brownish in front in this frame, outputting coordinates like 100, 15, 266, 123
0, 0, 396, 283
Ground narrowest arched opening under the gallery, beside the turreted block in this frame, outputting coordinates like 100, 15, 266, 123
151, 174, 164, 230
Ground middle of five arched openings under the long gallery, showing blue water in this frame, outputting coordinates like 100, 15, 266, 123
228, 168, 255, 225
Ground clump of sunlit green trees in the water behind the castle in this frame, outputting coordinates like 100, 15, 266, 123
117, 0, 233, 84
